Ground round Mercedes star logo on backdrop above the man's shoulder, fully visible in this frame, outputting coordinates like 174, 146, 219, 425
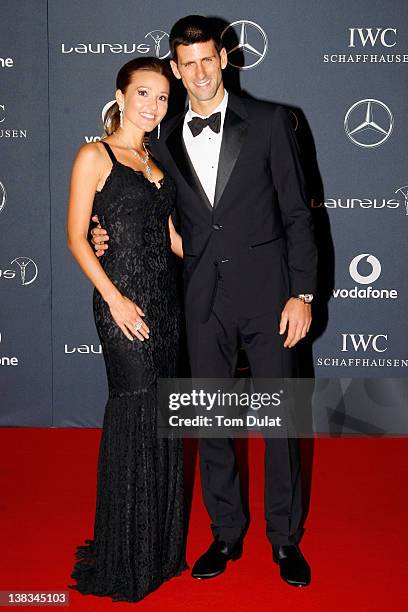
344, 98, 394, 148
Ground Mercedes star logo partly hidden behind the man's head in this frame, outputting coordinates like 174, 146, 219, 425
221, 19, 268, 70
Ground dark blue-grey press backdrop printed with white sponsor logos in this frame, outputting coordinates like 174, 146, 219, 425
0, 0, 408, 431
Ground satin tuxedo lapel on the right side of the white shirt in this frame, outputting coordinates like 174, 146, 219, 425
214, 103, 248, 208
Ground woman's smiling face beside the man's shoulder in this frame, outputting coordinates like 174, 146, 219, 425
116, 70, 170, 132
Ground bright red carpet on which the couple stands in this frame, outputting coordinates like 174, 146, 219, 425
0, 428, 408, 612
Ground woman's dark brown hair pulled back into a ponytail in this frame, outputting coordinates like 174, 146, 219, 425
103, 56, 172, 136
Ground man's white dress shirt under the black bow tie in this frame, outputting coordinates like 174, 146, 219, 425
183, 91, 228, 205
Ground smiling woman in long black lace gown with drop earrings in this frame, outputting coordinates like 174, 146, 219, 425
68, 58, 186, 601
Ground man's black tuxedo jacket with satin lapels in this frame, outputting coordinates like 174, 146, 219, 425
150, 93, 317, 328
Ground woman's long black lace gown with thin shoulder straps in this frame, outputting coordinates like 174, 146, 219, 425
69, 143, 187, 602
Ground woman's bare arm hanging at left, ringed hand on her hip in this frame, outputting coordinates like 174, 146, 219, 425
67, 144, 149, 340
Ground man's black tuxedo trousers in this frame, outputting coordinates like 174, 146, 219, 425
189, 276, 303, 546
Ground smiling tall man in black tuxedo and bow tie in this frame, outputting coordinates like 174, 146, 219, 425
93, 15, 317, 586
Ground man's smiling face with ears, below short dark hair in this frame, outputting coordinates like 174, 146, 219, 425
171, 40, 228, 102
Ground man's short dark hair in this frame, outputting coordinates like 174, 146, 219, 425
169, 15, 222, 61
